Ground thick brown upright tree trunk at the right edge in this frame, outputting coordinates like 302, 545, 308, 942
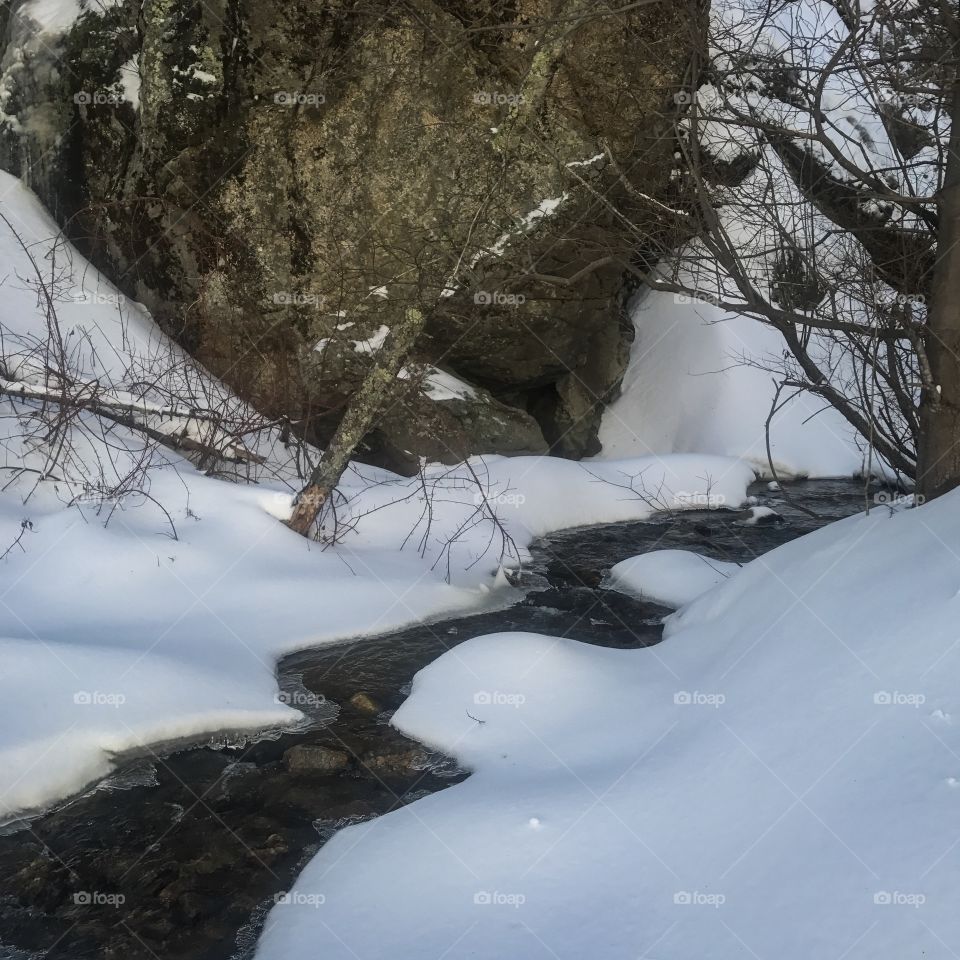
917, 63, 960, 500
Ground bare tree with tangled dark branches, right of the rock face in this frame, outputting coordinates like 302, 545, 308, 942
647, 0, 960, 497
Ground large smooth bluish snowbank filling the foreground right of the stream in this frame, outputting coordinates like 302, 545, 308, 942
257, 492, 960, 960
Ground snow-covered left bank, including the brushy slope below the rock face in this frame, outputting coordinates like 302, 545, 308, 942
0, 175, 753, 814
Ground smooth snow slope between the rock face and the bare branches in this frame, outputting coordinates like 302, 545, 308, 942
600, 290, 864, 477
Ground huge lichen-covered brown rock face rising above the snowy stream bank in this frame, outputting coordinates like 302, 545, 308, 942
0, 0, 689, 466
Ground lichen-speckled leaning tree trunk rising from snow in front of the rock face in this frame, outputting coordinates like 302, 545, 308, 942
287, 308, 425, 536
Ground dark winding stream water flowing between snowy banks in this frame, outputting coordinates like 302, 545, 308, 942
0, 481, 864, 960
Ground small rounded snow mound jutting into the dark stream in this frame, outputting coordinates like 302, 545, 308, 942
607, 550, 740, 607
